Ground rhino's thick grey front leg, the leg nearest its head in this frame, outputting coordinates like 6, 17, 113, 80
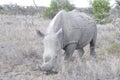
64, 43, 77, 61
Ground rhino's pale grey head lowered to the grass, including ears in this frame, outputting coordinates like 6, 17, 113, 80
36, 30, 62, 72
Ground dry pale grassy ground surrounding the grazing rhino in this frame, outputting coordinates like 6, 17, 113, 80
0, 15, 120, 80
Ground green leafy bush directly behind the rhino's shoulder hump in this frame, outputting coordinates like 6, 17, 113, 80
43, 0, 74, 18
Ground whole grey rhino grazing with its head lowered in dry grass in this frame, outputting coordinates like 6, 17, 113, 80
37, 10, 97, 72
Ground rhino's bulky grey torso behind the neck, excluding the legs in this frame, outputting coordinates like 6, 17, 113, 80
63, 11, 96, 47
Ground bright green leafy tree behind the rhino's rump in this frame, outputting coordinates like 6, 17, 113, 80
92, 0, 110, 22
